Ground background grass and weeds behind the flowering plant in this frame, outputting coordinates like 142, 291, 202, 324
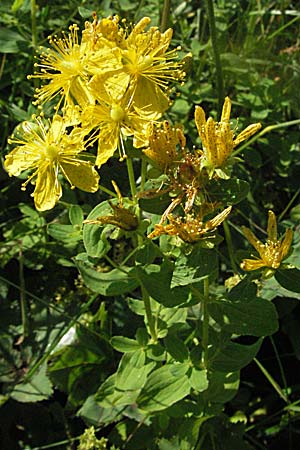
0, 0, 300, 450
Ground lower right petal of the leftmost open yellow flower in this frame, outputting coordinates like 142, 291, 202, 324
60, 161, 99, 192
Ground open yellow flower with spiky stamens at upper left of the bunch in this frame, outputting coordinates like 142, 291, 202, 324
29, 25, 93, 106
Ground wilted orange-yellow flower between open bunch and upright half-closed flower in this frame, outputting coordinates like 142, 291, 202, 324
143, 120, 186, 170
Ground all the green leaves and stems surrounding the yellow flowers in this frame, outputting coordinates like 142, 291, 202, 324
0, 0, 300, 450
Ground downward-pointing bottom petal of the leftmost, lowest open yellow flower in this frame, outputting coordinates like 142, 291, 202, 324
33, 164, 62, 211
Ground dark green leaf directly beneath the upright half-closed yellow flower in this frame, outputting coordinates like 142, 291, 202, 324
207, 178, 249, 205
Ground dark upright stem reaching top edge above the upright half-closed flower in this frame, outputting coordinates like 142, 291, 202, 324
206, 0, 224, 114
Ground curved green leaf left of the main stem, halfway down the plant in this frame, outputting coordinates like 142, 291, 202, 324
75, 258, 139, 296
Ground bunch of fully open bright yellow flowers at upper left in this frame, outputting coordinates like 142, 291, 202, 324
5, 16, 184, 211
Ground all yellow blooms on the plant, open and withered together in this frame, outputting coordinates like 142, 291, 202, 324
4, 15, 292, 270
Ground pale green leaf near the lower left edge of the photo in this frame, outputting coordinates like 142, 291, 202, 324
10, 364, 53, 403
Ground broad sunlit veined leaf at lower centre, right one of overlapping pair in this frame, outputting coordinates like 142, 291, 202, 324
137, 364, 190, 412
